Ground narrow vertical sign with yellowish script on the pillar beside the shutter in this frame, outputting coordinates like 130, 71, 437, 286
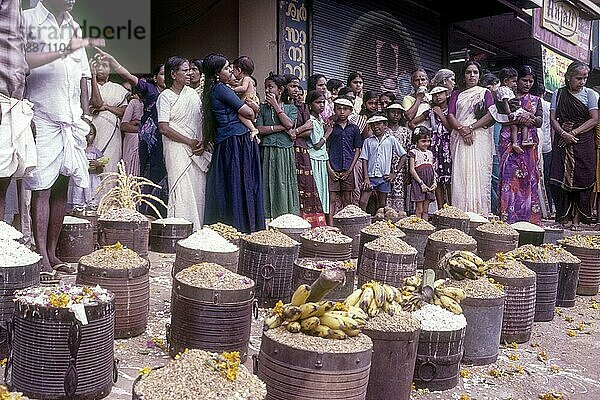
279, 0, 309, 88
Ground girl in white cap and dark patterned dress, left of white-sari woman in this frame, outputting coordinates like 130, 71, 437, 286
428, 86, 452, 208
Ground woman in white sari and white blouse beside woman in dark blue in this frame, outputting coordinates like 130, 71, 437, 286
156, 56, 210, 230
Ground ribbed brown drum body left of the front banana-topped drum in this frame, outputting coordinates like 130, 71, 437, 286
167, 277, 254, 363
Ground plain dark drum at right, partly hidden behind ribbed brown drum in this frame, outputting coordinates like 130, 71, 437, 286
521, 260, 558, 322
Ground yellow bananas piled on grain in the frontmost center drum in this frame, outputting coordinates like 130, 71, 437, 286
264, 285, 368, 339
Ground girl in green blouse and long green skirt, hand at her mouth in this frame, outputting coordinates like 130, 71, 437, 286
256, 75, 300, 219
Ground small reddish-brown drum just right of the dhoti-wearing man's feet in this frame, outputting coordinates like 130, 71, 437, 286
56, 222, 96, 263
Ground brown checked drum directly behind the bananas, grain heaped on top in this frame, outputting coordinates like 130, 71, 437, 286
357, 247, 417, 287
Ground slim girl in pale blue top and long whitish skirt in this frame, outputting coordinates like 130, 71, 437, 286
306, 90, 333, 214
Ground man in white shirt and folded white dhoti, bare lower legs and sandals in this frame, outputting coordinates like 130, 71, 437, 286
23, 0, 97, 280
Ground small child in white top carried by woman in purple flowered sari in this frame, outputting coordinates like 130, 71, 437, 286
496, 67, 534, 154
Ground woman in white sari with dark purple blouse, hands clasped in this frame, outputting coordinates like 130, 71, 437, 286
448, 61, 494, 215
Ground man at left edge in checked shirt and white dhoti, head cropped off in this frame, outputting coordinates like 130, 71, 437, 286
0, 0, 36, 217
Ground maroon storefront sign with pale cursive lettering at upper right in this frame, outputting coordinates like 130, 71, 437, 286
533, 5, 592, 63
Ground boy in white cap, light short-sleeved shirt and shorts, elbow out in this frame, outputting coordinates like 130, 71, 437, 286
360, 114, 406, 210
